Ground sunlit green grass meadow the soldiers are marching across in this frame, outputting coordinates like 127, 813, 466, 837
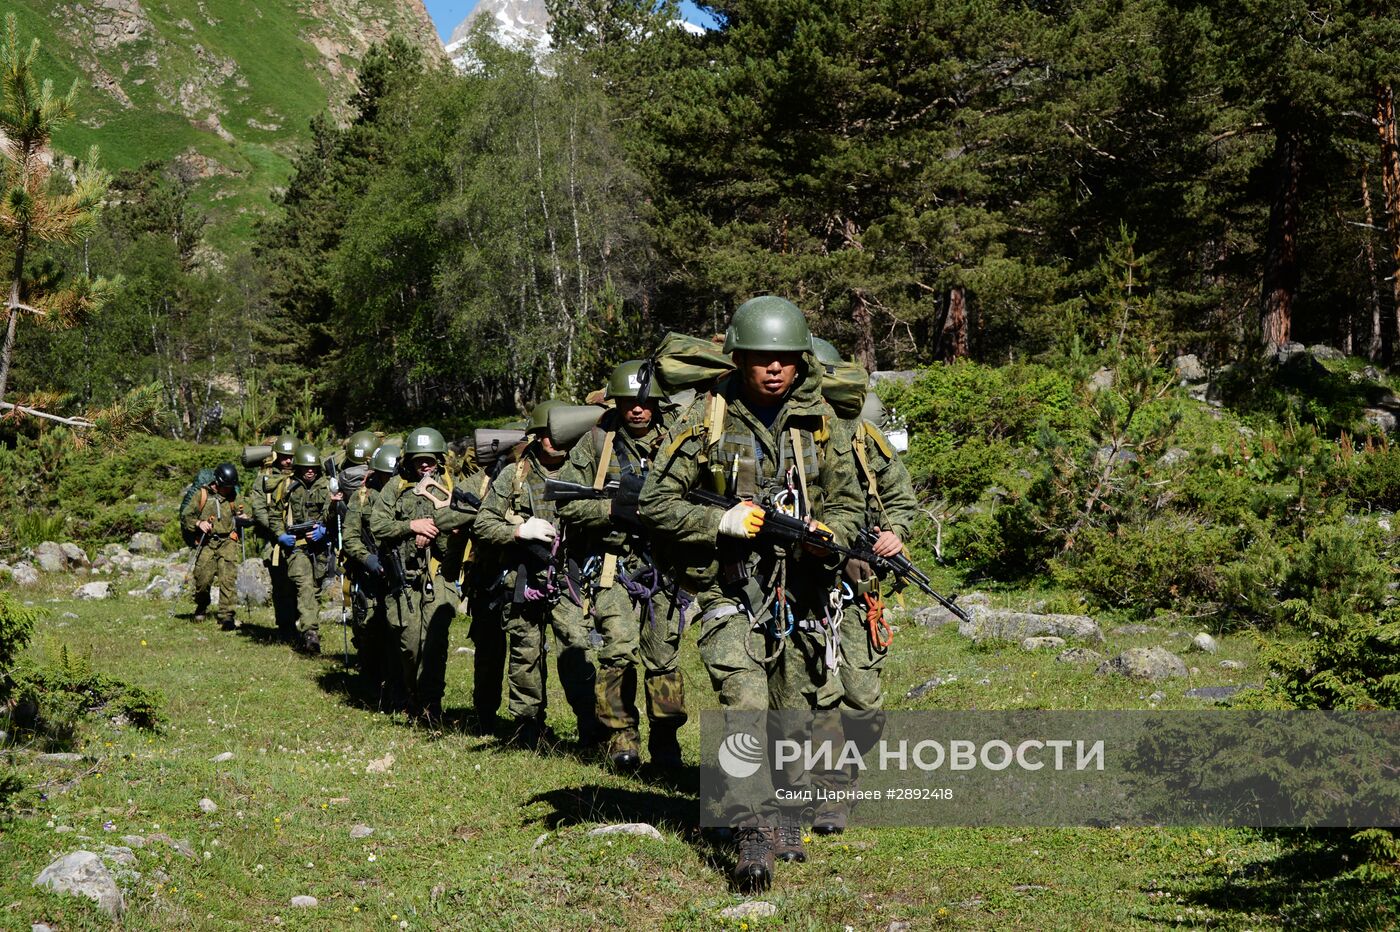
0, 576, 1400, 929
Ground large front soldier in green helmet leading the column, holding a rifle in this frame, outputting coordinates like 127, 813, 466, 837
640, 295, 864, 890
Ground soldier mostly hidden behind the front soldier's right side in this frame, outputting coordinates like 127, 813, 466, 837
812, 337, 918, 835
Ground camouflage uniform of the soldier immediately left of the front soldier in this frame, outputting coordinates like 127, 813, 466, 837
560, 411, 689, 756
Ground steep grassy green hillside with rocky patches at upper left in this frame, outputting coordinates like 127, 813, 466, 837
7, 0, 440, 249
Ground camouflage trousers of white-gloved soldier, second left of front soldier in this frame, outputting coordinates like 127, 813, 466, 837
505, 599, 598, 743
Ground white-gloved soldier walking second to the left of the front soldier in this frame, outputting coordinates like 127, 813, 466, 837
476, 400, 598, 747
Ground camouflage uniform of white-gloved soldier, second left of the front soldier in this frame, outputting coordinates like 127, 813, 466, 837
476, 442, 598, 743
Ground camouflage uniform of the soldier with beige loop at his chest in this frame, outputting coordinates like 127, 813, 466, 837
370, 476, 476, 715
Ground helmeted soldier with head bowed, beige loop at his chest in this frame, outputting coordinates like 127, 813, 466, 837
370, 427, 476, 725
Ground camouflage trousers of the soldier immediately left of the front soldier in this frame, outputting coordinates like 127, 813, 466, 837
594, 573, 686, 744
